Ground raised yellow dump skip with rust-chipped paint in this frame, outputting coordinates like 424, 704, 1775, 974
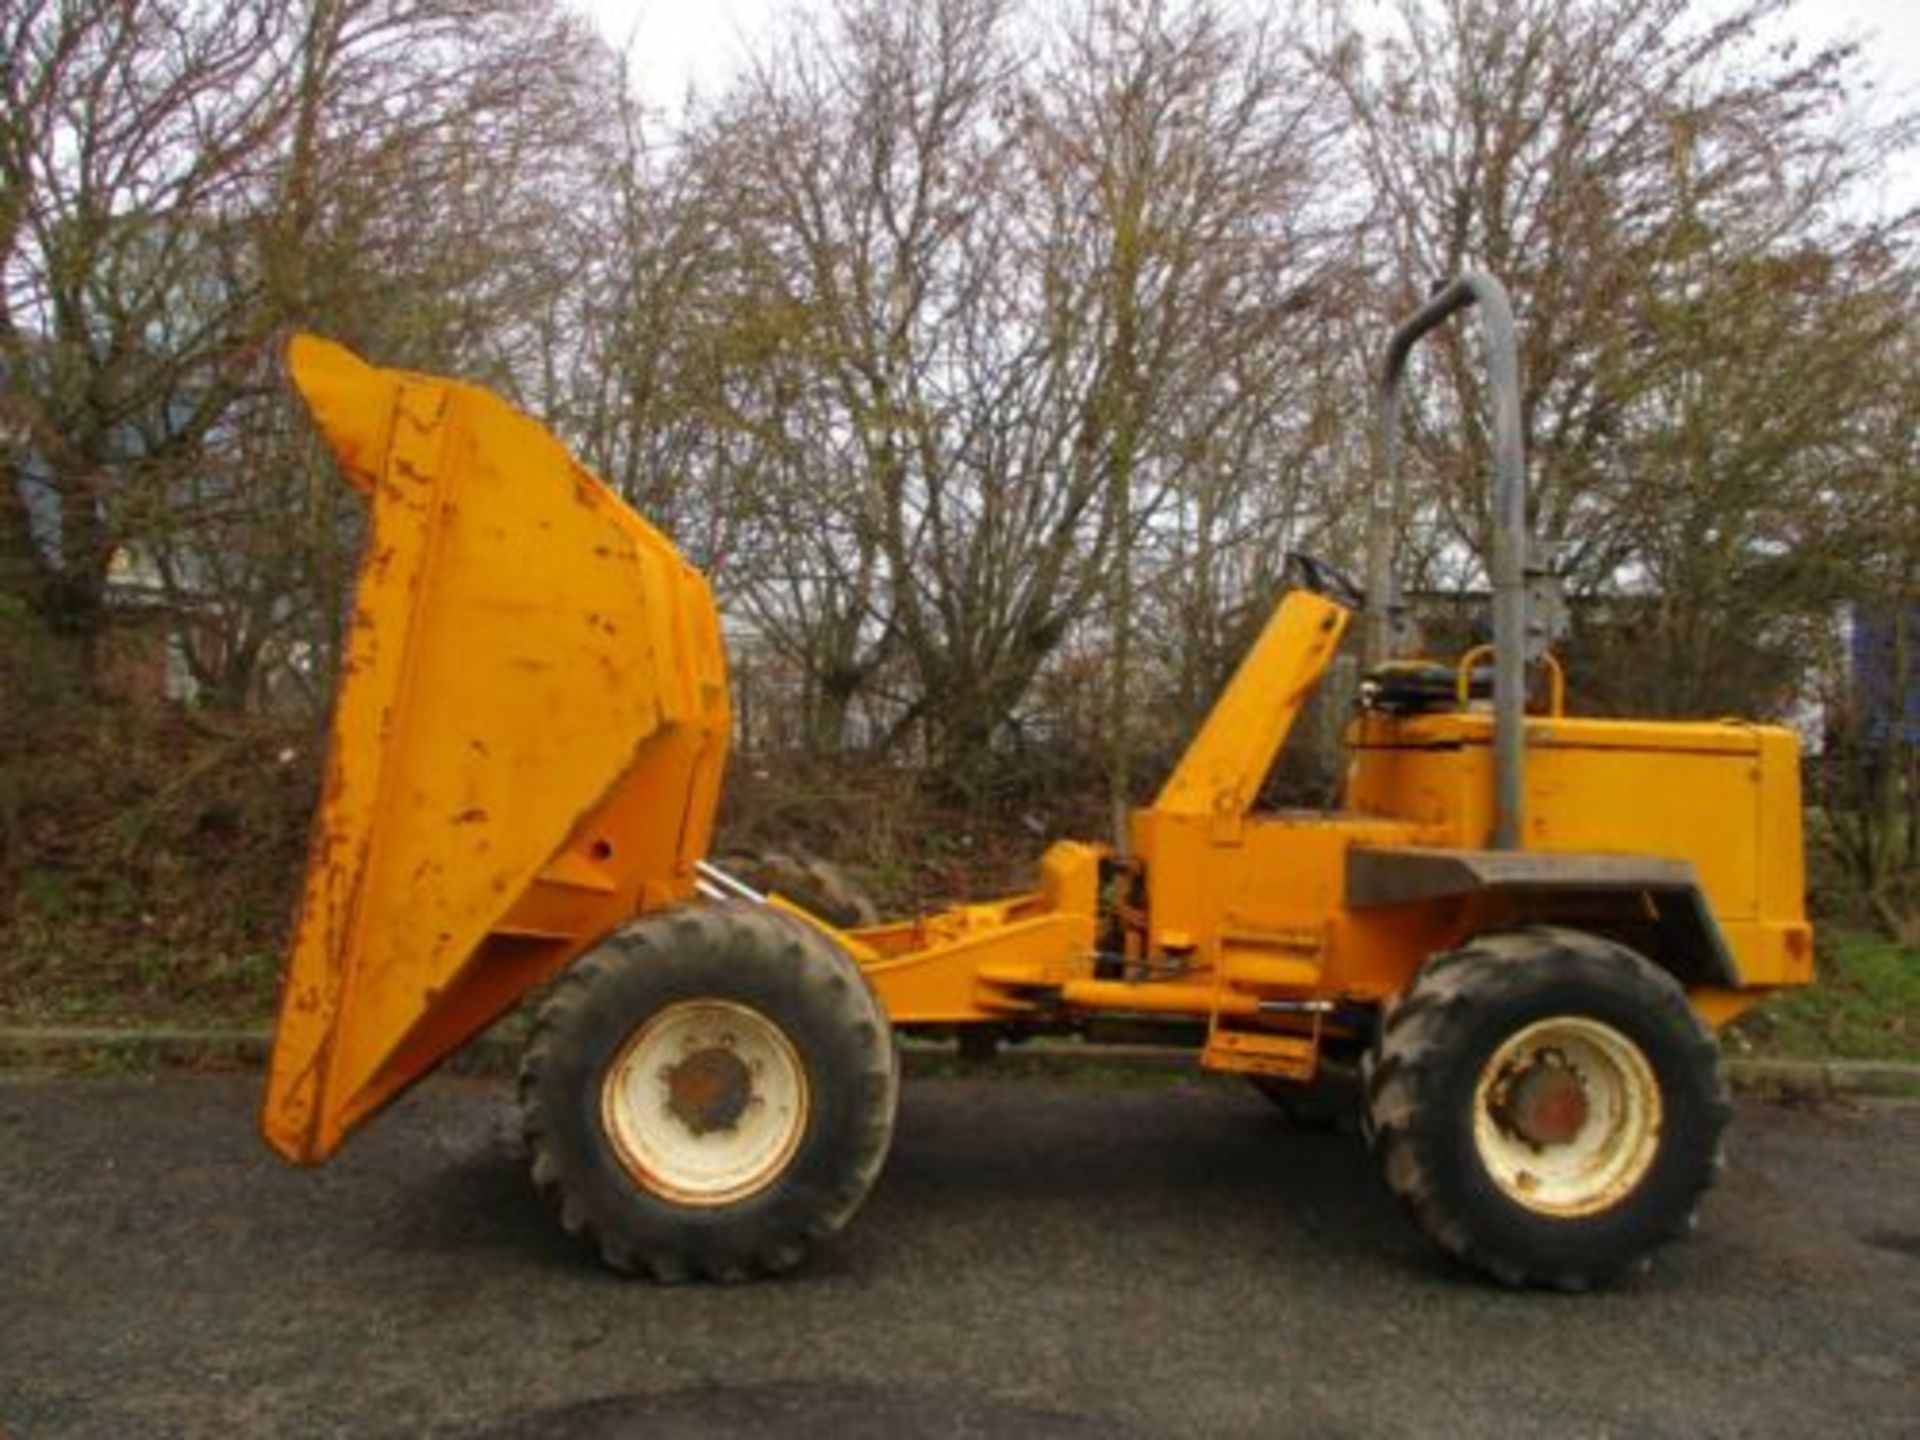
263, 336, 728, 1164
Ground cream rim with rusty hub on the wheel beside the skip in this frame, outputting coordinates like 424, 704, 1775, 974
601, 1000, 808, 1206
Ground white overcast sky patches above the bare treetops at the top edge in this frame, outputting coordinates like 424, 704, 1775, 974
576, 0, 1920, 205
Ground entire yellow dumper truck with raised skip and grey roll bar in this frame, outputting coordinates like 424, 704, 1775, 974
263, 275, 1812, 1288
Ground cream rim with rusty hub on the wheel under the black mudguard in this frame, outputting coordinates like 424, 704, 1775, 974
1473, 1016, 1661, 1217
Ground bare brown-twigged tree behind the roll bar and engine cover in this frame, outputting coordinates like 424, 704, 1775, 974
1319, 0, 1903, 714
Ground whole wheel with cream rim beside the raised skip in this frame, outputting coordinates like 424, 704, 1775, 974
520, 906, 899, 1281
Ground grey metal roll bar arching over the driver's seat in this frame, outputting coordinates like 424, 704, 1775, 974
1365, 271, 1526, 851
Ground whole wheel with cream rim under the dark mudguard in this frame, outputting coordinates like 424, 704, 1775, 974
1367, 927, 1732, 1290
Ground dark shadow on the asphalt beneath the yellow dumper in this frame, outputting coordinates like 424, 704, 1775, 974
388, 1077, 1484, 1286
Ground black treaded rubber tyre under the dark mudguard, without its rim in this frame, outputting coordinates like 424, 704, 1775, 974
1363, 925, 1732, 1290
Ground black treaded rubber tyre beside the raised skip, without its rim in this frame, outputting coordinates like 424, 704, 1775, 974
518, 906, 899, 1284
